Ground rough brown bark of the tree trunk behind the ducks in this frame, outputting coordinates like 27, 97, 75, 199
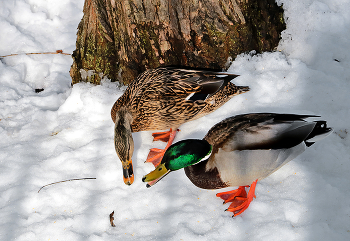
70, 0, 285, 84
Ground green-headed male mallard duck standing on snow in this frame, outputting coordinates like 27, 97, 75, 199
142, 113, 332, 216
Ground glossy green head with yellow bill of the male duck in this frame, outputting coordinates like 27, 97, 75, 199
142, 139, 212, 187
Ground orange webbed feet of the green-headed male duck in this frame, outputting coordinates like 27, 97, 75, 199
216, 180, 258, 216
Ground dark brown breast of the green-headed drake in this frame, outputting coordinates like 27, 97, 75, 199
185, 158, 228, 189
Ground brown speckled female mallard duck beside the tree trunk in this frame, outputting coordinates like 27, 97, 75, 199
111, 67, 249, 185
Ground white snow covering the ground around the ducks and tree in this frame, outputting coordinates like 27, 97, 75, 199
0, 0, 350, 241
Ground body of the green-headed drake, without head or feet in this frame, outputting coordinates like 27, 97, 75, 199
185, 113, 331, 189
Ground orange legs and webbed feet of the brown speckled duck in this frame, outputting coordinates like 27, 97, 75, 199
146, 129, 178, 167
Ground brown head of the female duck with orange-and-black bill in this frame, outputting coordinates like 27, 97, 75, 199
114, 109, 134, 185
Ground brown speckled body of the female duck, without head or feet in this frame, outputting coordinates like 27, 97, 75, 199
111, 68, 249, 132
